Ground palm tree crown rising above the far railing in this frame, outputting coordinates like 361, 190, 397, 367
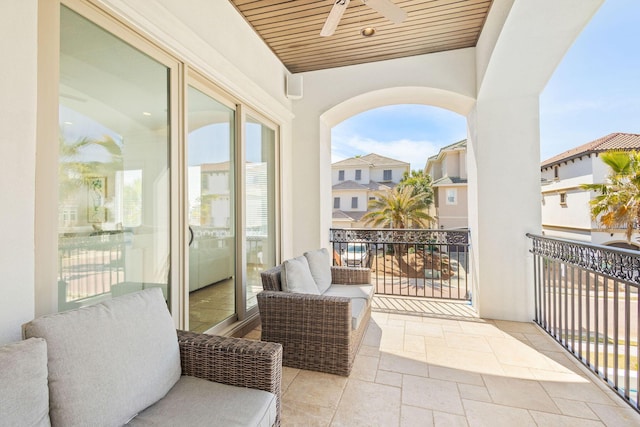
362, 185, 433, 228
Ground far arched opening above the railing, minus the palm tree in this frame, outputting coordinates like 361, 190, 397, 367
331, 104, 468, 229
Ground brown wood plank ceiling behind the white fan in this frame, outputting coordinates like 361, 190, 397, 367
230, 0, 492, 73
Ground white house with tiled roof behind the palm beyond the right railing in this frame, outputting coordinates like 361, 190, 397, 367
540, 133, 640, 249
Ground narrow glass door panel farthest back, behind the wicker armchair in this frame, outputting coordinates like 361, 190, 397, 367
244, 116, 276, 310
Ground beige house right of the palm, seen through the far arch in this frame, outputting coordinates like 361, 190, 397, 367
424, 139, 469, 228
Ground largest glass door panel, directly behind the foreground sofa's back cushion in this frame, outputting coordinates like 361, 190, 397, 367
58, 6, 170, 311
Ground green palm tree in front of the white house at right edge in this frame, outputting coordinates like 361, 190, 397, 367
581, 151, 640, 242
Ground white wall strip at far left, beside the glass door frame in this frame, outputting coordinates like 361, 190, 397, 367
0, 0, 38, 344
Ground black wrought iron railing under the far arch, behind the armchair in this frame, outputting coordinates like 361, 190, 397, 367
330, 228, 471, 300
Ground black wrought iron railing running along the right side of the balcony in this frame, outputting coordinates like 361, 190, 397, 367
527, 234, 640, 412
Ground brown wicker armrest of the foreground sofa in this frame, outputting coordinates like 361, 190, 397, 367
177, 330, 282, 426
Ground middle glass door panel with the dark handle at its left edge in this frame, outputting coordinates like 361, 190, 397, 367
187, 86, 236, 332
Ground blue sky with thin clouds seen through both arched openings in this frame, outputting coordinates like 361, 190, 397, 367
331, 0, 640, 173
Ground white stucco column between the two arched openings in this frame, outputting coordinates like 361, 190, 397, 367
468, 96, 541, 321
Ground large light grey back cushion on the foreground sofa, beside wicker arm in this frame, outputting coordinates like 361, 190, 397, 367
24, 288, 182, 427
